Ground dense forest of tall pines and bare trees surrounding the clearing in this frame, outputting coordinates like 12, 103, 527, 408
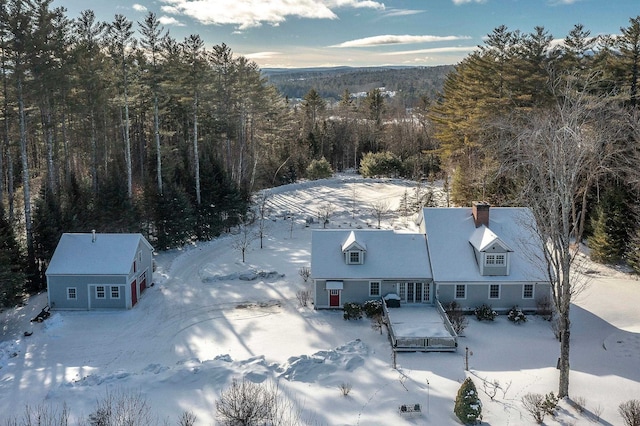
0, 0, 640, 312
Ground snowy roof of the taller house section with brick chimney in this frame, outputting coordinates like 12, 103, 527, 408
422, 207, 544, 282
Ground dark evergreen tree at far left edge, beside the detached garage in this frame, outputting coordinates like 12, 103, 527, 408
0, 204, 25, 306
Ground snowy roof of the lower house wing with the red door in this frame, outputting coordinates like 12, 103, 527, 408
311, 229, 431, 279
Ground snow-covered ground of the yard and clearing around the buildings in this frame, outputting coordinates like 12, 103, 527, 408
0, 176, 640, 425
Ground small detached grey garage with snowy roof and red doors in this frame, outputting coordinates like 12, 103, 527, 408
46, 232, 153, 310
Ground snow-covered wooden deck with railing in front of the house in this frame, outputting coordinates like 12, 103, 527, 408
382, 300, 458, 352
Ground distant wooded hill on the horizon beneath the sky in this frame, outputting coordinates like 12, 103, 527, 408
262, 65, 453, 104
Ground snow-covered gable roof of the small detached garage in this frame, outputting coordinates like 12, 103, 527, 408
47, 233, 152, 275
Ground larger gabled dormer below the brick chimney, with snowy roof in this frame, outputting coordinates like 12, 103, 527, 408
469, 225, 513, 275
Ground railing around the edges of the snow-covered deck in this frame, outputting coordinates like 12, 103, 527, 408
382, 299, 458, 352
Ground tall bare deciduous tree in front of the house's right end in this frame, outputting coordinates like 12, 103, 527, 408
499, 76, 626, 397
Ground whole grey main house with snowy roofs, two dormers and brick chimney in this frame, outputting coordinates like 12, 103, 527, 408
311, 203, 550, 310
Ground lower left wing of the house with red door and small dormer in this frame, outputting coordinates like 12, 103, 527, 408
311, 229, 433, 308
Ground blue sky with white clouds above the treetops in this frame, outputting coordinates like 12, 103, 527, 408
53, 0, 640, 68
